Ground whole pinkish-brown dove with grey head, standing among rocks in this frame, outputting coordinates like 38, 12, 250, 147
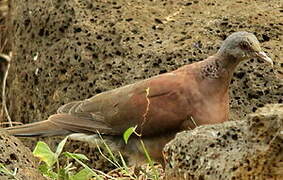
7, 32, 273, 163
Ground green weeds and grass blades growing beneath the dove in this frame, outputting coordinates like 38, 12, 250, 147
32, 127, 159, 180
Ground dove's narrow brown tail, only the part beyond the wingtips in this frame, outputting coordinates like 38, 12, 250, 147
6, 120, 71, 137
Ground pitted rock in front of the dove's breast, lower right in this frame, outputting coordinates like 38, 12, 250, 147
164, 104, 283, 180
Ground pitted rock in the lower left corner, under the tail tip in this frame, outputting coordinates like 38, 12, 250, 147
0, 129, 45, 180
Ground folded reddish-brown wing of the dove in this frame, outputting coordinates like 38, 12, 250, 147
49, 73, 191, 135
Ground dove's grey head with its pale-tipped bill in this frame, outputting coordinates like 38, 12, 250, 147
218, 32, 273, 65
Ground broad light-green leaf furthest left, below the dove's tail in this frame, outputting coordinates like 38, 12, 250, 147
32, 141, 57, 167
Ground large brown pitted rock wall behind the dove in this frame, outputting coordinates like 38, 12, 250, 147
1, 0, 283, 177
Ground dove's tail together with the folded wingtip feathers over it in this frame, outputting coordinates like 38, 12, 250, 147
6, 113, 114, 137
